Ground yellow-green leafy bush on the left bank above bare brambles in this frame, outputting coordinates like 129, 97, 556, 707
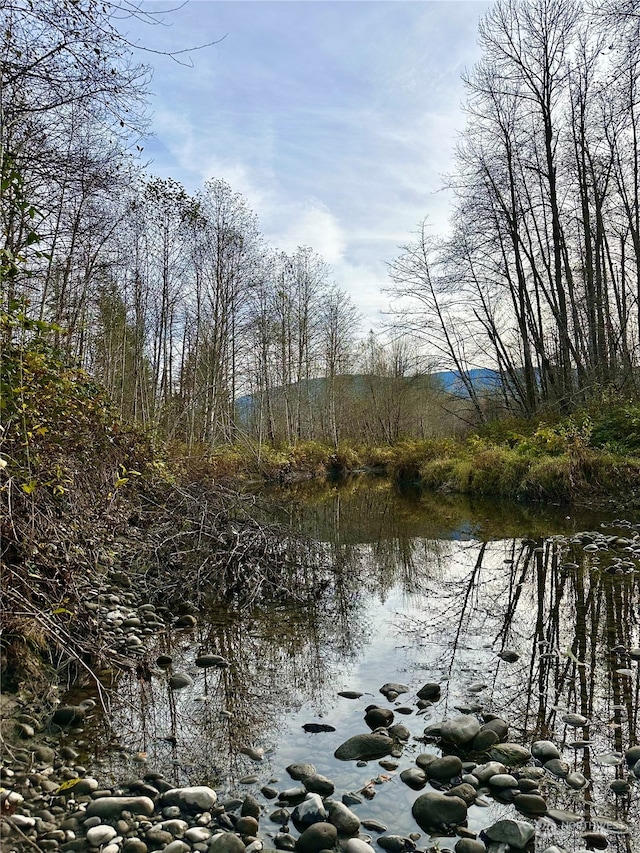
0, 303, 147, 498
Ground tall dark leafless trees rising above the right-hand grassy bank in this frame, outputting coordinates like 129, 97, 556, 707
391, 0, 640, 415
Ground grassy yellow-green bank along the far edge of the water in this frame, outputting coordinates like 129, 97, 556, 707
190, 424, 640, 507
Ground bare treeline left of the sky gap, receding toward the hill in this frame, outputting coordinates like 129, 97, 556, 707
0, 0, 458, 448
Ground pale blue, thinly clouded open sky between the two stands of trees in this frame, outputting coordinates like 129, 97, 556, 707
121, 0, 490, 329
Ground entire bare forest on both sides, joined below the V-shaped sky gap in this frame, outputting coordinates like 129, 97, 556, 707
0, 0, 640, 450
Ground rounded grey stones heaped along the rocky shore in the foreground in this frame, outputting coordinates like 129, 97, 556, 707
1, 683, 640, 853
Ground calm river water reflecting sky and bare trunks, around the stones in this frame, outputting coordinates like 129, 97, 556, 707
69, 479, 640, 853
